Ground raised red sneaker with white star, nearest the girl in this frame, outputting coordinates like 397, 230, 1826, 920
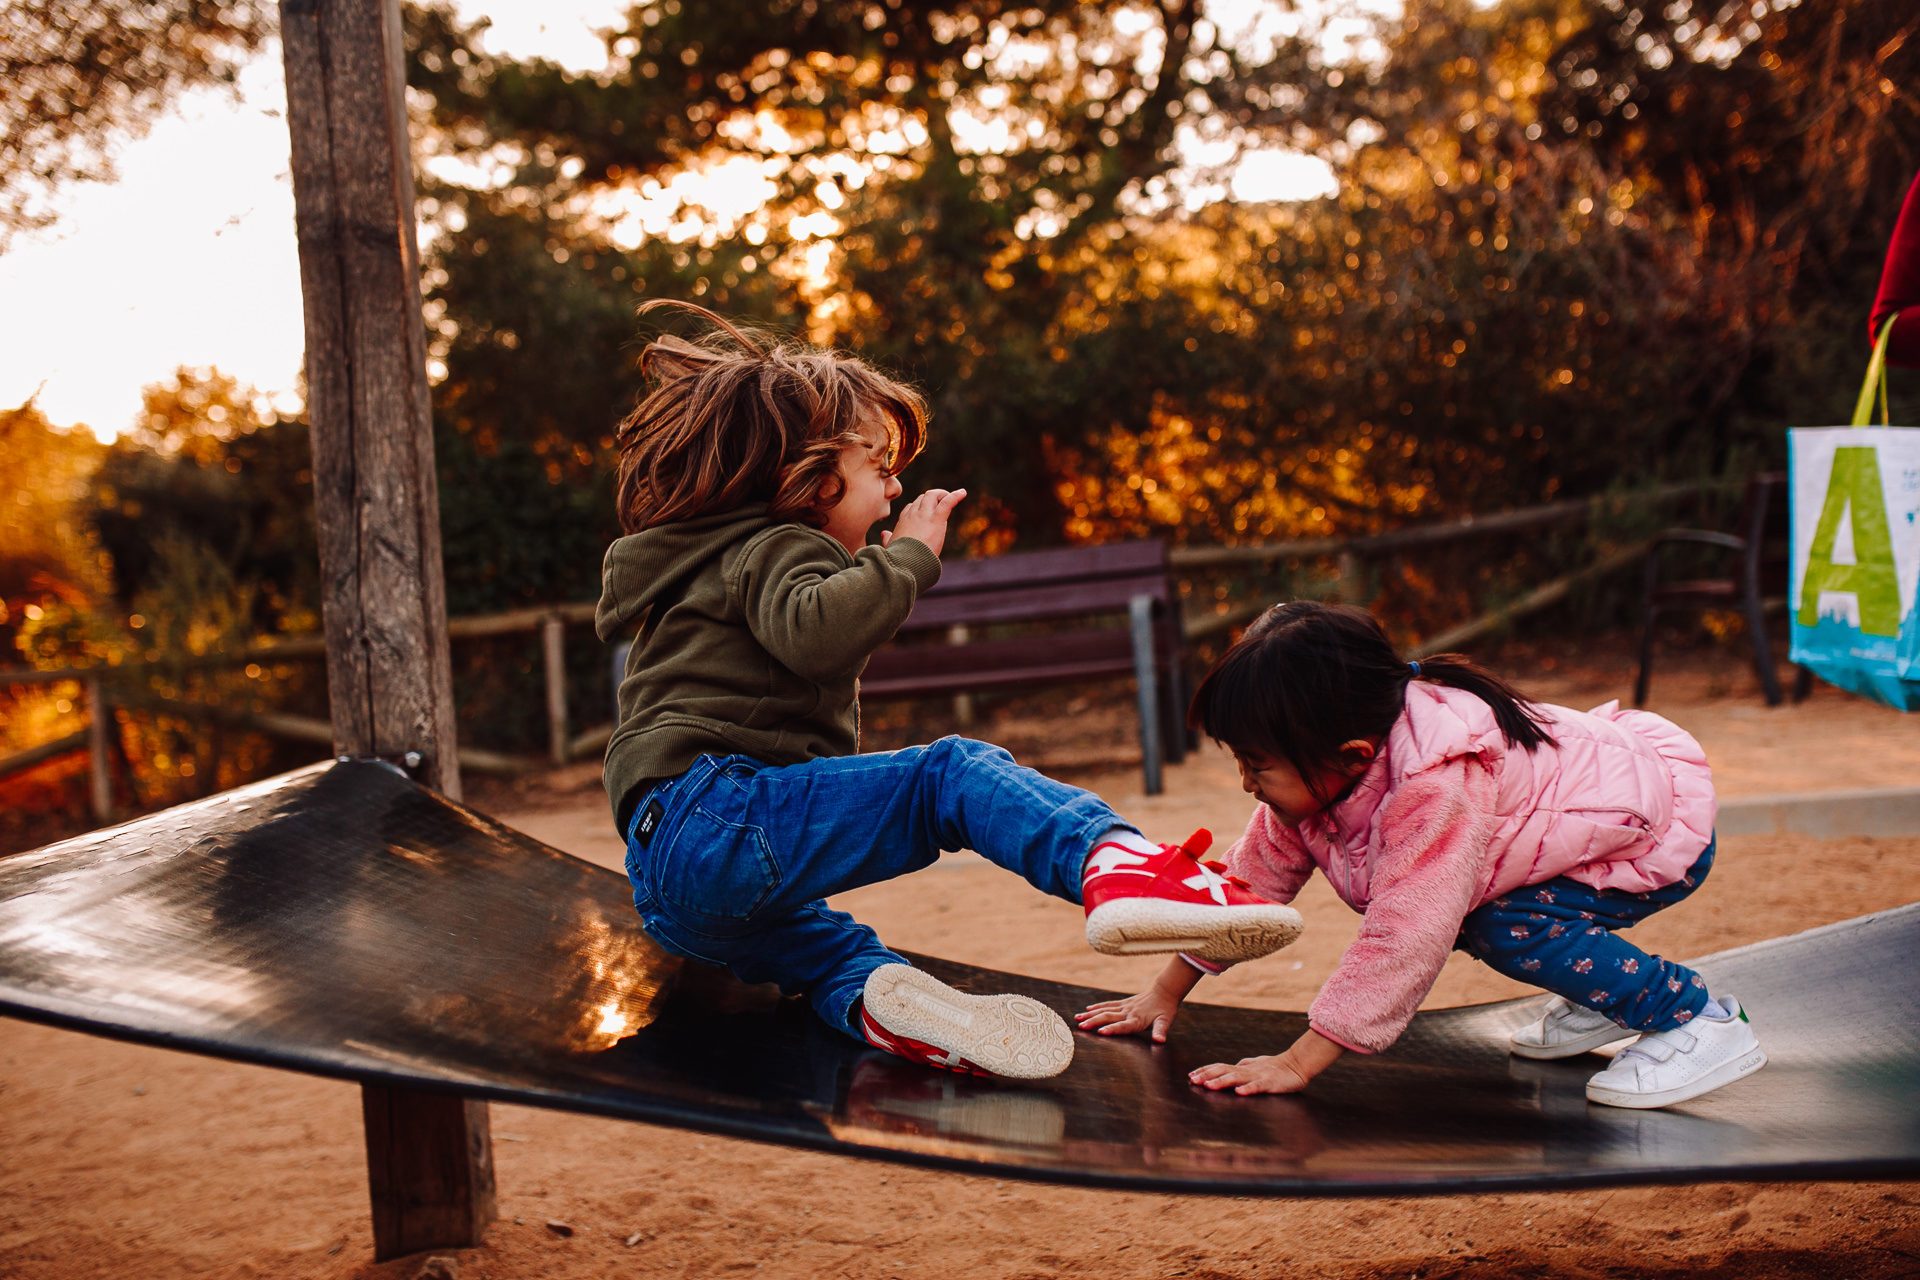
1081, 831, 1302, 963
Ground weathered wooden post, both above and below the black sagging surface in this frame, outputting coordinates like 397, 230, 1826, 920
280, 0, 493, 1261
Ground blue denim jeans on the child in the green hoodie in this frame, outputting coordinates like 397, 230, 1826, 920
626, 737, 1131, 1038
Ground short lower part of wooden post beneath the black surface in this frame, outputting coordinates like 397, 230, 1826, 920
361, 1084, 495, 1263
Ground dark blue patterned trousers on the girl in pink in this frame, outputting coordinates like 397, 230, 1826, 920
1455, 841, 1715, 1031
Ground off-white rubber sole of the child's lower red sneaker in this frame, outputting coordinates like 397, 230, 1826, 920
864, 965, 1073, 1080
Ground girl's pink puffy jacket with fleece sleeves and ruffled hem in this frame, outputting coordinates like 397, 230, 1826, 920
1227, 681, 1718, 1054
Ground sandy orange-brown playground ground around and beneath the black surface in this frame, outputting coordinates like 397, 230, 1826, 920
0, 668, 1920, 1280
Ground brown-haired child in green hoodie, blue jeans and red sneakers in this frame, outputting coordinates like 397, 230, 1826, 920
595, 303, 1300, 1079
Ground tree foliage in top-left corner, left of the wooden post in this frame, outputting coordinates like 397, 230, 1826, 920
0, 0, 276, 251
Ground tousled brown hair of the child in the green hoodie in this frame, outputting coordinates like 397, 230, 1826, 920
616, 299, 927, 533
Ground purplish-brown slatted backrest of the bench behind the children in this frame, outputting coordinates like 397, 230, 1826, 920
900, 541, 1173, 631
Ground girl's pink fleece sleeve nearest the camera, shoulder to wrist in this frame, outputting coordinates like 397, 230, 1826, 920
1308, 756, 1496, 1054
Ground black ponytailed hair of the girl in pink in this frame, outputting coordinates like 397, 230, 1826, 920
1187, 601, 1553, 785
